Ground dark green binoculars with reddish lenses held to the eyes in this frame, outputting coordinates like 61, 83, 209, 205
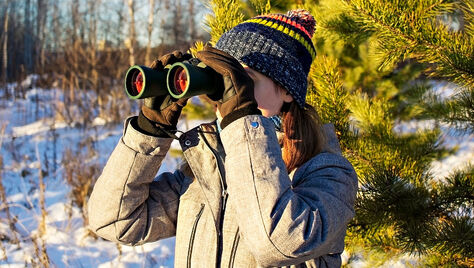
125, 58, 224, 100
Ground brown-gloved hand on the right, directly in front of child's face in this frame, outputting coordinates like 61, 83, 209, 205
197, 46, 262, 129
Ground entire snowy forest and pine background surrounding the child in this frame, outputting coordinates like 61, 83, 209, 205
0, 0, 474, 267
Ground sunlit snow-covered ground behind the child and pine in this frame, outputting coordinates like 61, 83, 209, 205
0, 78, 474, 267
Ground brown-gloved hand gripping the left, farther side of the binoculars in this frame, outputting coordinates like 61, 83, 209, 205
138, 50, 192, 137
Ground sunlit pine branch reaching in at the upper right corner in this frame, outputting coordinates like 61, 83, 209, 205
343, 0, 474, 87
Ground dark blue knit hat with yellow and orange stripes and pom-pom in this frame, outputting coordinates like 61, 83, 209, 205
216, 9, 316, 107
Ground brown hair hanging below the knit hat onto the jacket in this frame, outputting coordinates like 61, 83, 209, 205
282, 101, 326, 173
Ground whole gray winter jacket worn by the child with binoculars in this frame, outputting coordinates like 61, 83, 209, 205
88, 115, 357, 268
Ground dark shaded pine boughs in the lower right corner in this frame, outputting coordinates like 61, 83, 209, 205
356, 165, 474, 263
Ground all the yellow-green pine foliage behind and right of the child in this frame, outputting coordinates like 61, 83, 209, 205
208, 0, 474, 267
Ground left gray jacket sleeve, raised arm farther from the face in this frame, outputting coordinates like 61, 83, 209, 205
88, 117, 185, 245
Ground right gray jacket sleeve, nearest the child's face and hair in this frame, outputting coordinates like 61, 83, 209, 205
221, 115, 357, 267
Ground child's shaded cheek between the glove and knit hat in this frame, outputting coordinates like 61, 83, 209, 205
244, 65, 293, 117
